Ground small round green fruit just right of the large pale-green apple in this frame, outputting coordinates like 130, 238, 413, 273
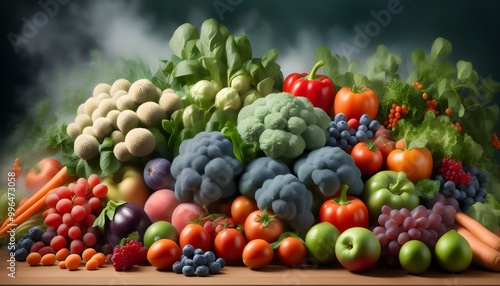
399, 239, 432, 274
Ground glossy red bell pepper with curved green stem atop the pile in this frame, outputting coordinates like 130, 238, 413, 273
283, 61, 335, 115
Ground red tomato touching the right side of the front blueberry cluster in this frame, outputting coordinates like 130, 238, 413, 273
214, 228, 246, 263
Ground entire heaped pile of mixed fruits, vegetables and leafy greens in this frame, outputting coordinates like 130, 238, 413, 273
0, 16, 500, 276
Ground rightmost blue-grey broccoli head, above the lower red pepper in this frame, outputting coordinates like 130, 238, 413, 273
293, 146, 364, 196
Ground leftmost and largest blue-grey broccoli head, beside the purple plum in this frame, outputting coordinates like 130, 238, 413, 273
170, 131, 244, 206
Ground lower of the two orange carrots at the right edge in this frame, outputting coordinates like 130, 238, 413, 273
454, 224, 500, 271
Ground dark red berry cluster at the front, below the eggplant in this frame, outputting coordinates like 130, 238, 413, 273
111, 238, 148, 271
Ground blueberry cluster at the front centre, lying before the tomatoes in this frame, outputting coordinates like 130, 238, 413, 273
172, 244, 226, 277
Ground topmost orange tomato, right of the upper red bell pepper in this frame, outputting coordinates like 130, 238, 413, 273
333, 86, 378, 119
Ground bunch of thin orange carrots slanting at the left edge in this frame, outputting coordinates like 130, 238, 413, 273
0, 167, 74, 237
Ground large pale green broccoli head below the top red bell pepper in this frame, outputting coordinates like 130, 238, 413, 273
237, 92, 330, 162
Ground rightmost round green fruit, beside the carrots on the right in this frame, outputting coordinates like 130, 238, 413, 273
434, 229, 472, 272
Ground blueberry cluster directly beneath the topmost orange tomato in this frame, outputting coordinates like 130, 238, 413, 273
325, 113, 380, 153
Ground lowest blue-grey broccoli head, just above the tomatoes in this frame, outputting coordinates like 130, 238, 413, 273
255, 174, 314, 232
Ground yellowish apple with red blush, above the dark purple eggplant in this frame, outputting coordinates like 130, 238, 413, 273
102, 165, 151, 207
